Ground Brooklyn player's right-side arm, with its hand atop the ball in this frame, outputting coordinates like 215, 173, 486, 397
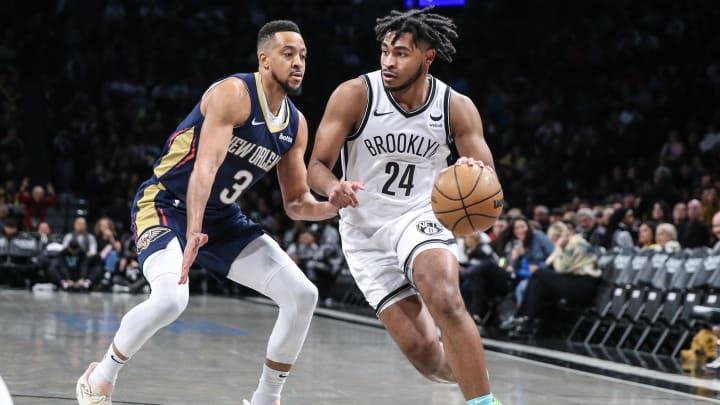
450, 92, 495, 168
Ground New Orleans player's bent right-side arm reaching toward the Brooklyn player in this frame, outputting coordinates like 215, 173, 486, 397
277, 112, 337, 221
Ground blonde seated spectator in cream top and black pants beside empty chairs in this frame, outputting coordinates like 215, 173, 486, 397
510, 224, 602, 338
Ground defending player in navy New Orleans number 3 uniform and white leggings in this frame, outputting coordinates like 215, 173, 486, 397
77, 21, 337, 405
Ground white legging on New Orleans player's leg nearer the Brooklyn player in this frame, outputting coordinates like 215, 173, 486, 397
228, 235, 317, 364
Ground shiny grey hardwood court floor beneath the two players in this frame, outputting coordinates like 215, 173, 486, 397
0, 290, 720, 405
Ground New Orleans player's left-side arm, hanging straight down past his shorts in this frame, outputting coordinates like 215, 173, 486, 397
179, 78, 250, 284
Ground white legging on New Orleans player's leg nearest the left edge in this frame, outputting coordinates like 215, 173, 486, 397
114, 238, 189, 358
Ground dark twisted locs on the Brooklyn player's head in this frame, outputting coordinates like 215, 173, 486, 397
375, 8, 458, 62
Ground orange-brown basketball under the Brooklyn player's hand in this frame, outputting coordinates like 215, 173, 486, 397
430, 164, 503, 236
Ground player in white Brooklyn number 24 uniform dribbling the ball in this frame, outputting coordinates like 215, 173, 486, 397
308, 10, 500, 405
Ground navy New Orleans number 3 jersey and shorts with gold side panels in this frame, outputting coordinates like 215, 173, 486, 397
132, 73, 299, 273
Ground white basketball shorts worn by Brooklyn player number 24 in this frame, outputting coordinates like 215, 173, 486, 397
340, 206, 457, 315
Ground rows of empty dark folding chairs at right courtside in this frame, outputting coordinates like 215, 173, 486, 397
567, 248, 720, 357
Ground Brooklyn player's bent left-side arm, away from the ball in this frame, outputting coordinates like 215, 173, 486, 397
307, 78, 367, 208
